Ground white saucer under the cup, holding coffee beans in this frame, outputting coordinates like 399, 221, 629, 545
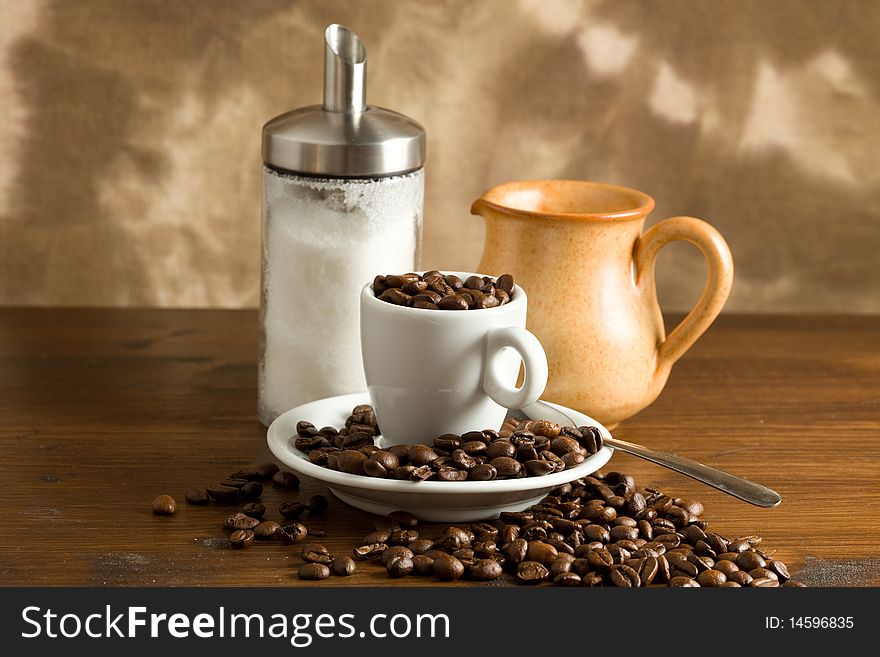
267, 392, 614, 522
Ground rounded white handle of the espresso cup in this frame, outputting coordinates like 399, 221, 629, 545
483, 326, 548, 409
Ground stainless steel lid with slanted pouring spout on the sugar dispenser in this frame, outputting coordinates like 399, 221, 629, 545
263, 24, 425, 177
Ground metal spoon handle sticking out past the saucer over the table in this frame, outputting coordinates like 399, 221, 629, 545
605, 438, 782, 508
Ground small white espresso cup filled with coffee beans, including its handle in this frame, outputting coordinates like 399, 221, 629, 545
361, 272, 547, 445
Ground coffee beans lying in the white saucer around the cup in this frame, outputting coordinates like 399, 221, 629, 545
294, 405, 602, 481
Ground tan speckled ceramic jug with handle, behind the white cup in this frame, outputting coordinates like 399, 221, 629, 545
471, 180, 733, 427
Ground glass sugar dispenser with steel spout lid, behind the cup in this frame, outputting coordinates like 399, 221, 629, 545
258, 25, 426, 425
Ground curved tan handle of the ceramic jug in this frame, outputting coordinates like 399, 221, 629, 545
634, 217, 733, 371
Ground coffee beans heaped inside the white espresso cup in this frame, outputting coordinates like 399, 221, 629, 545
373, 270, 513, 310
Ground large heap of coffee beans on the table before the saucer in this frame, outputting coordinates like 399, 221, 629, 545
344, 472, 803, 587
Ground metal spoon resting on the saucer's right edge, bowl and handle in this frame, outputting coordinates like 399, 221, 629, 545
513, 400, 782, 509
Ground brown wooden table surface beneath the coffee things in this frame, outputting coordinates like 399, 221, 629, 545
0, 309, 880, 586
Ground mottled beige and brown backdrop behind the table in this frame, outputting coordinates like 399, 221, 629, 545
0, 0, 880, 313
